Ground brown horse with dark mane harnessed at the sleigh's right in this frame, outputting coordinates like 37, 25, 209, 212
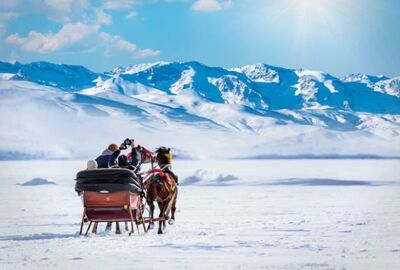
145, 147, 178, 234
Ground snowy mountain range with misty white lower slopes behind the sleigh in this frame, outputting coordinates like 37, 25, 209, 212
0, 62, 400, 159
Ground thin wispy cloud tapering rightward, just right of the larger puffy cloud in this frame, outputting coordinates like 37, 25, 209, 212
100, 32, 160, 58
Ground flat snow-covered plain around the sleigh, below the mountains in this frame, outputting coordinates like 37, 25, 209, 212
0, 160, 400, 270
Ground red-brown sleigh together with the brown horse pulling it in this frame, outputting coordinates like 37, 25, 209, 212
75, 148, 178, 235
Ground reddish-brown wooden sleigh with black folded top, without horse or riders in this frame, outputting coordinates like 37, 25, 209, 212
75, 169, 147, 235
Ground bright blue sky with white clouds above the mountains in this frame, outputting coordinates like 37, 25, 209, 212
0, 0, 400, 77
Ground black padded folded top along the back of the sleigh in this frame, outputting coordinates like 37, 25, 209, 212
75, 168, 142, 194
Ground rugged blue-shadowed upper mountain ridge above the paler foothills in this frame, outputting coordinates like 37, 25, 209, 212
0, 62, 400, 117
